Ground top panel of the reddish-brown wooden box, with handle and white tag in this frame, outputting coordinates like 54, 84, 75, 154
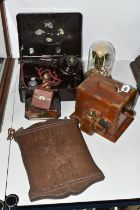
78, 74, 137, 110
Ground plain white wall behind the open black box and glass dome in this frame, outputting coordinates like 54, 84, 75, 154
5, 0, 140, 60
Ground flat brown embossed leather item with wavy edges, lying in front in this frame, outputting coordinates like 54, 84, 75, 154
14, 119, 104, 201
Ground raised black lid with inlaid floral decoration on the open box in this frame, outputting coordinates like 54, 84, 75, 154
17, 13, 82, 57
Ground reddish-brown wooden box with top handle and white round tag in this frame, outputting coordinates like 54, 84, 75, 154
70, 74, 137, 142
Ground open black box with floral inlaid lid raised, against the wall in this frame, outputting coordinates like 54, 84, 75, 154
17, 13, 84, 102
